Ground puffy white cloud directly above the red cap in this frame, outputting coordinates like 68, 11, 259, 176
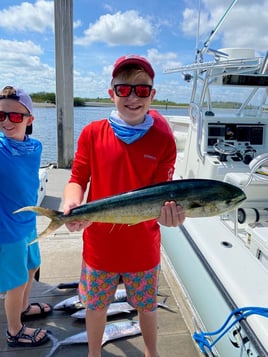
75, 10, 154, 46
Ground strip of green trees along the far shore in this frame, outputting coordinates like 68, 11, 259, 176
30, 92, 185, 107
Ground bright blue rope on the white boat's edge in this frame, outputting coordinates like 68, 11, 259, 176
193, 306, 268, 354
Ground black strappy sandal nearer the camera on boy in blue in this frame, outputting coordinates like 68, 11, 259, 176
6, 325, 49, 347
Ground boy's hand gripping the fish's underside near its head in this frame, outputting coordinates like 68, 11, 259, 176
158, 201, 185, 227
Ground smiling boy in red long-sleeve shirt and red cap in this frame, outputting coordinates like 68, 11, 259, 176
64, 55, 184, 357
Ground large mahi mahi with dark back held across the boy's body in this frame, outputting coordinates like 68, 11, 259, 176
14, 179, 246, 238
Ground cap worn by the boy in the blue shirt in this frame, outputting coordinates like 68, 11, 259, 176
0, 86, 33, 134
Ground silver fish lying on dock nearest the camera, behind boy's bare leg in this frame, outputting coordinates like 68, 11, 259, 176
46, 320, 141, 357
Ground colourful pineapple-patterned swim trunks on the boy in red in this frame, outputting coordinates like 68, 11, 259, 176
79, 261, 160, 312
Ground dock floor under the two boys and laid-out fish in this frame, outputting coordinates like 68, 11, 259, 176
0, 169, 200, 357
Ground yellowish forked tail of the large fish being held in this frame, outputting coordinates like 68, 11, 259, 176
13, 206, 64, 244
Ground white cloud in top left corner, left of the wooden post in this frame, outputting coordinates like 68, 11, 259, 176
0, 0, 54, 33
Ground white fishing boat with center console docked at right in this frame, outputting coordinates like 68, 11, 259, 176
161, 3, 268, 357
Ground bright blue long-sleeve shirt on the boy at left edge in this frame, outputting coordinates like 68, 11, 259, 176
0, 133, 42, 244
